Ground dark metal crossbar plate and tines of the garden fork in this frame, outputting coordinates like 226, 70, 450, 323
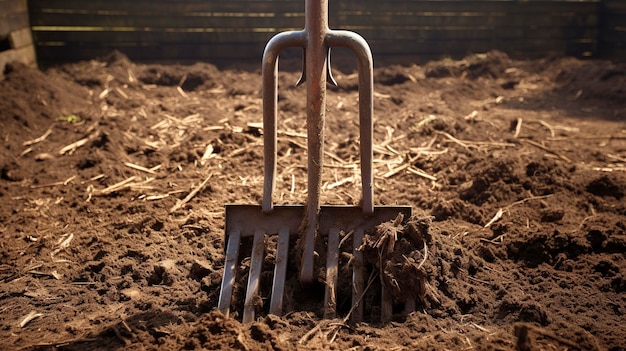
218, 205, 411, 323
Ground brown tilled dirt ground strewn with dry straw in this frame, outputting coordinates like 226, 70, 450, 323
0, 52, 626, 350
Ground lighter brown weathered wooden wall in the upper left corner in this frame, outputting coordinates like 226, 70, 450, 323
0, 0, 35, 77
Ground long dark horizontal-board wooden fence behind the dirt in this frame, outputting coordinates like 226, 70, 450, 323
29, 0, 626, 62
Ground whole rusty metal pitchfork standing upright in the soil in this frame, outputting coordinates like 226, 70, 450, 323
218, 0, 411, 323
